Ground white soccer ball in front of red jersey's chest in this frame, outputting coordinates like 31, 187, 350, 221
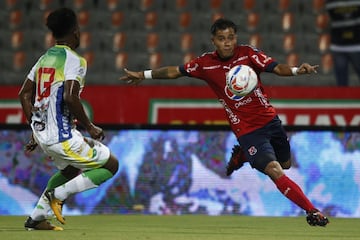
226, 65, 258, 96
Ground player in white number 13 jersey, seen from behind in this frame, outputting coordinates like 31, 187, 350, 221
19, 8, 118, 230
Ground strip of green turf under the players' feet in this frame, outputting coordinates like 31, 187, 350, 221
0, 215, 360, 240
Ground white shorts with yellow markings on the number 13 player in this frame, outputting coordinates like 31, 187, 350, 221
39, 129, 110, 170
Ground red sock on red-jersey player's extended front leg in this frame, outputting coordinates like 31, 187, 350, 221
274, 175, 315, 212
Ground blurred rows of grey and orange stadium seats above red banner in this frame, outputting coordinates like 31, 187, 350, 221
0, 0, 359, 86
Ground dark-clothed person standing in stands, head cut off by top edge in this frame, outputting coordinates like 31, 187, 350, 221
325, 0, 360, 86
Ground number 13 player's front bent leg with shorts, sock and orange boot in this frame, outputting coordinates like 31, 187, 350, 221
42, 131, 118, 224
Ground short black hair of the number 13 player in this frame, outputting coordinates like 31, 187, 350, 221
46, 7, 77, 38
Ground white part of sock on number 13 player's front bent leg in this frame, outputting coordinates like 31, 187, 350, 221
54, 174, 98, 201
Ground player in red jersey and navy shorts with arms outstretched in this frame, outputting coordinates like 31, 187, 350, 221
120, 19, 329, 226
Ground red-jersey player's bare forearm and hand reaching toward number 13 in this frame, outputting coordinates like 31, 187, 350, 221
120, 66, 183, 85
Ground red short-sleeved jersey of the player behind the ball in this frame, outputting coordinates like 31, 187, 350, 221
180, 45, 277, 138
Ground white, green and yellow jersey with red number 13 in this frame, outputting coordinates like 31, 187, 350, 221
27, 45, 87, 145
